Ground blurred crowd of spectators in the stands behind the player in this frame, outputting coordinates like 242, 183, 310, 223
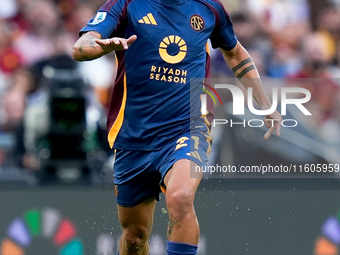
0, 0, 340, 179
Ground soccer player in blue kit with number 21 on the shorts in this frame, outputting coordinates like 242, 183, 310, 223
73, 0, 282, 255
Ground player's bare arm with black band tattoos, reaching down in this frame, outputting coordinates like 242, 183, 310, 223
221, 42, 282, 140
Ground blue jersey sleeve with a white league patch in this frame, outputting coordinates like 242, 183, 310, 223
79, 0, 126, 39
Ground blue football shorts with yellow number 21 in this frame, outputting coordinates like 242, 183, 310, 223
114, 122, 212, 207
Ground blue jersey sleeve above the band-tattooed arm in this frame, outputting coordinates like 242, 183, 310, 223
210, 0, 237, 50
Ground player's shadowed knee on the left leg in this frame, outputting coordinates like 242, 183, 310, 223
123, 226, 149, 254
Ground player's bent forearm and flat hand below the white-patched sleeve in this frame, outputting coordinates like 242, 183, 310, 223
72, 31, 137, 61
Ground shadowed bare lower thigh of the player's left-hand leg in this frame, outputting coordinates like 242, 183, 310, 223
117, 198, 156, 236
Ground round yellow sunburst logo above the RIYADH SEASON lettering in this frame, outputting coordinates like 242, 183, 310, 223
159, 35, 188, 64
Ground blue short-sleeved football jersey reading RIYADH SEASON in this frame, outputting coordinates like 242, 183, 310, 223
80, 0, 237, 150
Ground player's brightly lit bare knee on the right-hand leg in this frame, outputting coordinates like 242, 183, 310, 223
166, 189, 194, 218
